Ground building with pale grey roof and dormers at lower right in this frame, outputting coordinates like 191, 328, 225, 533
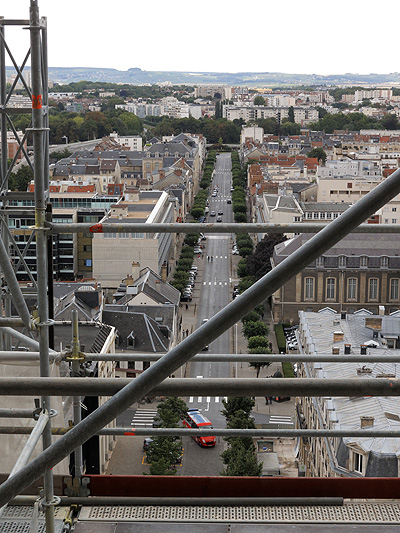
296, 308, 400, 478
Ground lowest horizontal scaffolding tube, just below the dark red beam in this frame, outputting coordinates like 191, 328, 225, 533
10, 496, 343, 507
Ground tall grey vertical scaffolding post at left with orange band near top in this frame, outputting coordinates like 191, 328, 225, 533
29, 0, 55, 533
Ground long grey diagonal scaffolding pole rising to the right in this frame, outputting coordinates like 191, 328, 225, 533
0, 139, 400, 505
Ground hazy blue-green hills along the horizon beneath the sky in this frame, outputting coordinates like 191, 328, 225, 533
7, 67, 400, 86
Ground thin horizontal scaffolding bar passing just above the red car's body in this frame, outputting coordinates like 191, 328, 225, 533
0, 422, 400, 439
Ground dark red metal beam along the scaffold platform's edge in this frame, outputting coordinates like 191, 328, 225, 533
85, 475, 400, 499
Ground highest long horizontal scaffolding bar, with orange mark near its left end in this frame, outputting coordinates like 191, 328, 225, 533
46, 222, 400, 233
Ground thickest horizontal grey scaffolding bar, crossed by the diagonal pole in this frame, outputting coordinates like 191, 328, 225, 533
0, 376, 400, 397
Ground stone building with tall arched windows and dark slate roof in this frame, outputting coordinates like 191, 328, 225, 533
271, 231, 400, 323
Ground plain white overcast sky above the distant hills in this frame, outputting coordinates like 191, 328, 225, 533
0, 0, 400, 75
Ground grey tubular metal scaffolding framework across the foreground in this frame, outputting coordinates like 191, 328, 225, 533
0, 0, 400, 533
